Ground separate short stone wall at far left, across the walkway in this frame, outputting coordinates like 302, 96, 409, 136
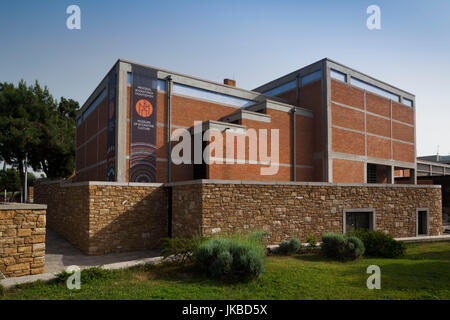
0, 203, 46, 277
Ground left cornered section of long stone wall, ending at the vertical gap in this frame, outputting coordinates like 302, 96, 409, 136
34, 182, 168, 255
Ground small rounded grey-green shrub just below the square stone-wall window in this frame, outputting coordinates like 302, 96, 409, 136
322, 233, 364, 261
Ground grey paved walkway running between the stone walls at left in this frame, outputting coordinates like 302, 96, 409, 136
45, 228, 160, 273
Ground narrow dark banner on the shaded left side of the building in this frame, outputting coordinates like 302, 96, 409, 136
106, 70, 117, 181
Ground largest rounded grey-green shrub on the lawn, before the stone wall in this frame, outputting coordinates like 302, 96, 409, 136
194, 233, 266, 278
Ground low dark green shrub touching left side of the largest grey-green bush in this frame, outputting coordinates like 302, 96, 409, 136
161, 237, 205, 264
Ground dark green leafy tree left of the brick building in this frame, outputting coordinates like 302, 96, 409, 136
0, 80, 78, 195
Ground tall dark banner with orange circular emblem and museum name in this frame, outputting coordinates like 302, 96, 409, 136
130, 65, 158, 182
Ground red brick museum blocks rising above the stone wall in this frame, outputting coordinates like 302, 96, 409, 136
75, 59, 416, 184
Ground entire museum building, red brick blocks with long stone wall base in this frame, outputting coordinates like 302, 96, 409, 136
30, 59, 443, 254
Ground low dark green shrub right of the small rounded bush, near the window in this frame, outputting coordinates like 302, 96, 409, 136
349, 230, 406, 258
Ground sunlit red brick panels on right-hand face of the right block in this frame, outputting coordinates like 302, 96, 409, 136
331, 80, 415, 182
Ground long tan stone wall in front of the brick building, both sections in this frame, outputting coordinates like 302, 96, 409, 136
35, 180, 442, 254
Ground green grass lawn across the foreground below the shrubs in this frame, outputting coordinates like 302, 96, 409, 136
0, 242, 450, 299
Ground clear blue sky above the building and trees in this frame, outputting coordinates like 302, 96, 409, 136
0, 0, 450, 155
